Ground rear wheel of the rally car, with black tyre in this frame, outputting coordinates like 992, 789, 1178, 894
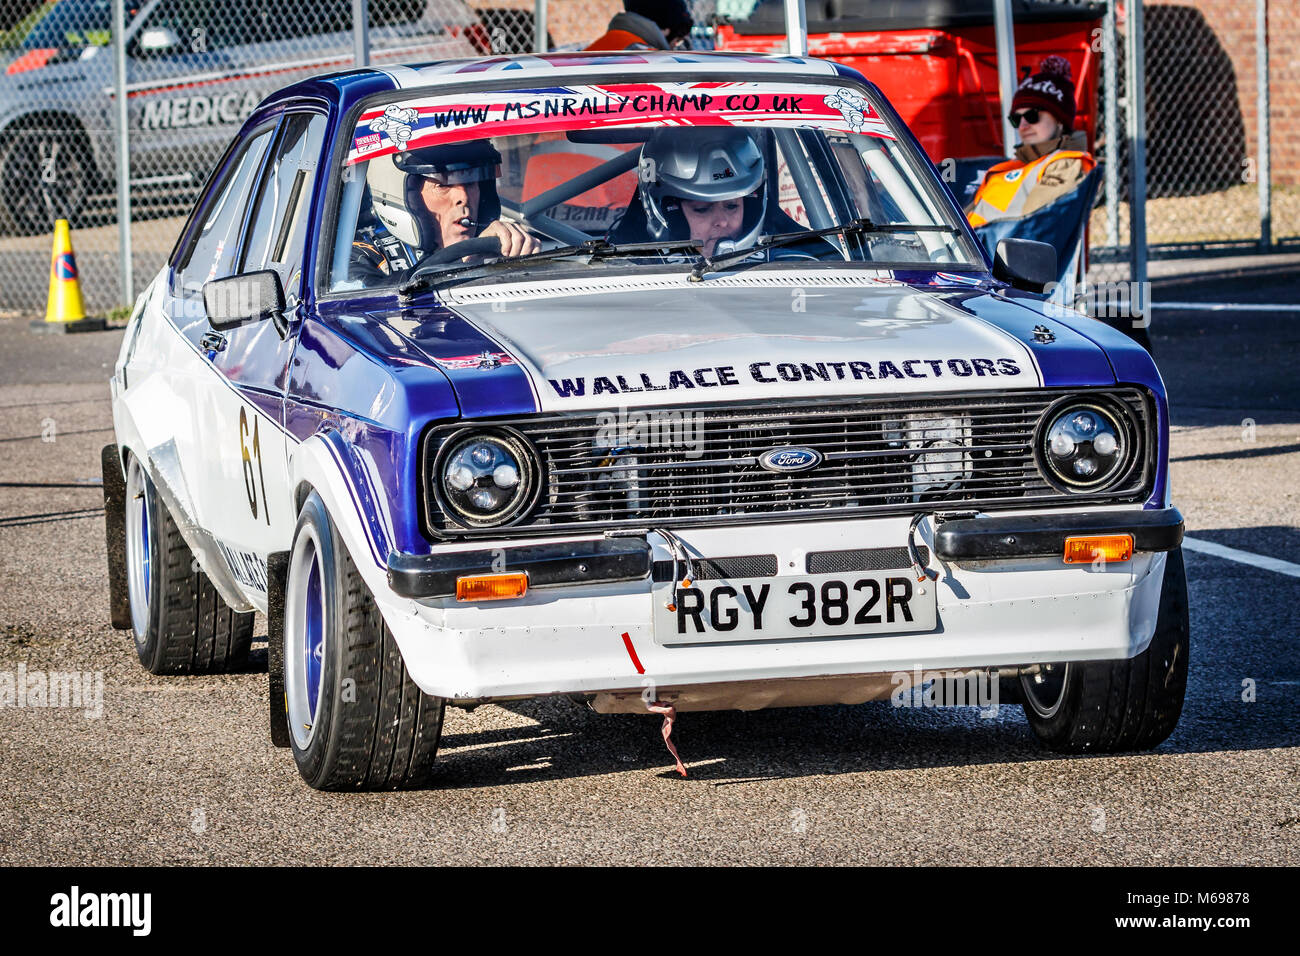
124, 457, 254, 674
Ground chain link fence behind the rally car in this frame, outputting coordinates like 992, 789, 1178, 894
0, 0, 1300, 312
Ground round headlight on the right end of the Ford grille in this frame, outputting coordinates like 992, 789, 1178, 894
1039, 401, 1138, 492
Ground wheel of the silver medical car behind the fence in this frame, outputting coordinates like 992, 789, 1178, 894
0, 121, 96, 235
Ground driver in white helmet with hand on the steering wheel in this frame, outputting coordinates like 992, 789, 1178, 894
351, 139, 540, 278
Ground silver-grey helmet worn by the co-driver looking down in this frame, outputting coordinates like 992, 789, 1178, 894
641, 126, 767, 254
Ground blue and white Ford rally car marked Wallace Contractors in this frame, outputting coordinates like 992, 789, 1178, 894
104, 52, 1188, 790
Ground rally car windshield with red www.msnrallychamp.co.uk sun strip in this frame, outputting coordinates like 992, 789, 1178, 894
329, 82, 983, 291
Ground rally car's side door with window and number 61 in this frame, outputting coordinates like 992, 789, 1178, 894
194, 112, 326, 604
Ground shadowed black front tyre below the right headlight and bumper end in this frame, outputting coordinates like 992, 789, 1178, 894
1021, 549, 1190, 753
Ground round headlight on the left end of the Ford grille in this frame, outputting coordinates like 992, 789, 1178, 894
433, 432, 537, 527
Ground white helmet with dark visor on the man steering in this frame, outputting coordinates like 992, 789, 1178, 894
365, 139, 501, 251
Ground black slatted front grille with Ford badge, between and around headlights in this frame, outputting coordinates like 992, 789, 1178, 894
424, 389, 1153, 537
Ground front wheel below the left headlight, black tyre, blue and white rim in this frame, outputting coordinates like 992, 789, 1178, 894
283, 492, 445, 790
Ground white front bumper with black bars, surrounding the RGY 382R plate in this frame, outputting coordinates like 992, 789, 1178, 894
376, 509, 1182, 701
